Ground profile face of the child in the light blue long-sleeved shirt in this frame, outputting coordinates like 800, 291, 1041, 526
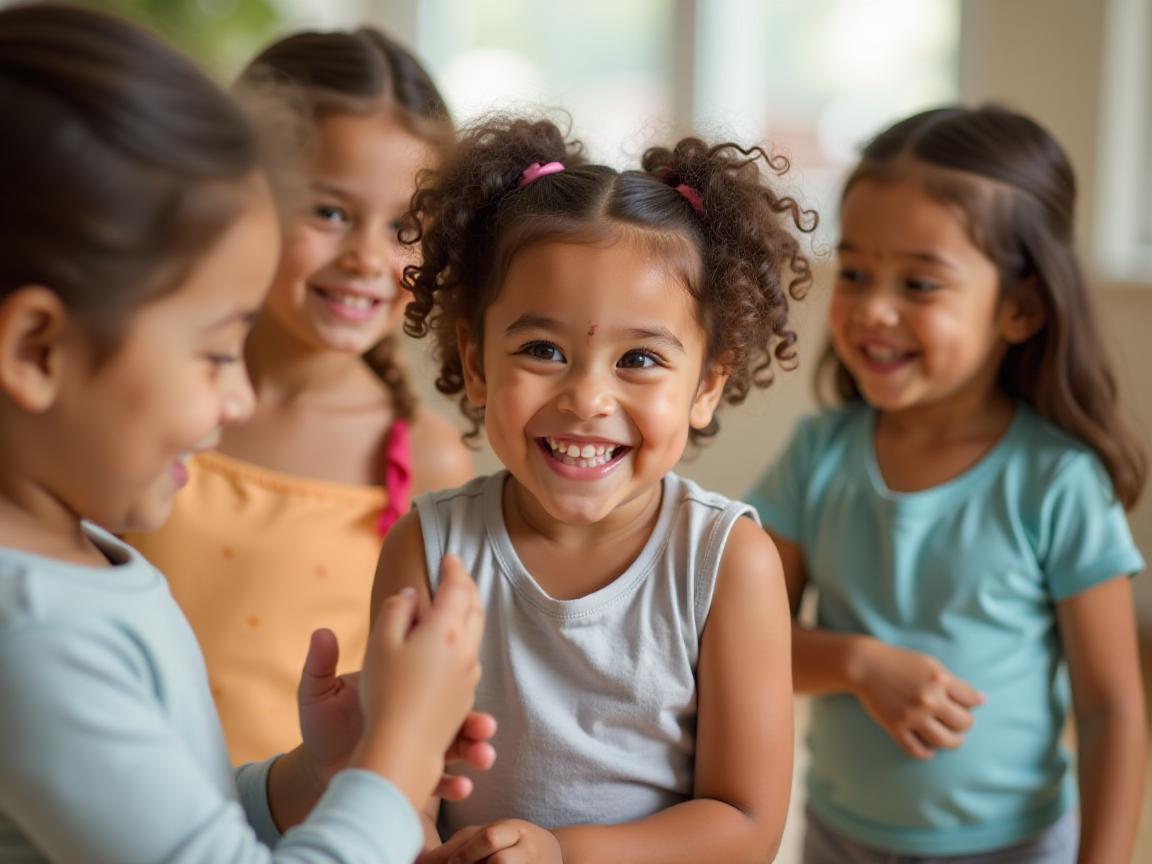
53, 183, 280, 531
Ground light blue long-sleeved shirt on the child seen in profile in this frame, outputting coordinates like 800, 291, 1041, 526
0, 526, 423, 864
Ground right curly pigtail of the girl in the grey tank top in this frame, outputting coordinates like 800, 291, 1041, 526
641, 138, 818, 437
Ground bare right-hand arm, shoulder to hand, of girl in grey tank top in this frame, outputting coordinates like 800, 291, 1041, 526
429, 520, 793, 864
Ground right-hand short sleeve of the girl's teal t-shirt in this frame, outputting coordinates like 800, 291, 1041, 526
1038, 452, 1144, 600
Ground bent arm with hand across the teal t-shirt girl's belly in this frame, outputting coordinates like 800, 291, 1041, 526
773, 536, 984, 759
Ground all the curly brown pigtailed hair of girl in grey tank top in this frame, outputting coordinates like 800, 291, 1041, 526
401, 115, 817, 444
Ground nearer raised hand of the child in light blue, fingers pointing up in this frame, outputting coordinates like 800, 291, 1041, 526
350, 555, 484, 808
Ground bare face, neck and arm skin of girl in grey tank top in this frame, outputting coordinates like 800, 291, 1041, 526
374, 236, 793, 864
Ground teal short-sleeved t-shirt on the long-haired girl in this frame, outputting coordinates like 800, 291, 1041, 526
749, 404, 1144, 855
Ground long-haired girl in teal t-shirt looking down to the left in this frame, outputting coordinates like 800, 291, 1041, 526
751, 107, 1145, 864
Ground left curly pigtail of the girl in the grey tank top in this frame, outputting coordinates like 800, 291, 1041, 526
400, 116, 584, 439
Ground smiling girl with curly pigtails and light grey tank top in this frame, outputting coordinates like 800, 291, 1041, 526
368, 119, 809, 864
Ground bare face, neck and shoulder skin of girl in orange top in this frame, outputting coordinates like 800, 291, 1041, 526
220, 112, 472, 494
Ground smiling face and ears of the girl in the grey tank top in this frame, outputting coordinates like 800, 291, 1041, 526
462, 242, 725, 524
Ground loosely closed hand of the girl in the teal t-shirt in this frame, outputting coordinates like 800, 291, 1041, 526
854, 639, 984, 759
